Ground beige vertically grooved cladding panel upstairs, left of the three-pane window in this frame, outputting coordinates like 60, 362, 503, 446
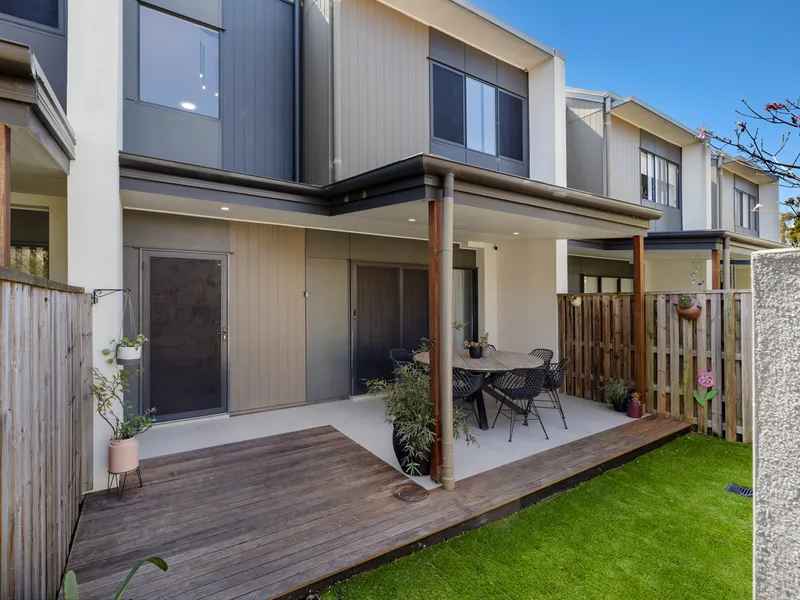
341, 0, 430, 178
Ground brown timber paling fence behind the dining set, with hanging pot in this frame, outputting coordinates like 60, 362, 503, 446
558, 290, 753, 443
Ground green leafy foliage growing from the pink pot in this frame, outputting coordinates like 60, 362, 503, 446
92, 368, 156, 440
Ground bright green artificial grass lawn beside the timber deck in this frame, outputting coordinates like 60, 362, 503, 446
323, 435, 752, 600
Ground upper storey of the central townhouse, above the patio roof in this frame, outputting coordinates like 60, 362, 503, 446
111, 0, 566, 185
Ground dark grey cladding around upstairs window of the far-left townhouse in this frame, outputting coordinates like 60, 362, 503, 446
0, 0, 67, 108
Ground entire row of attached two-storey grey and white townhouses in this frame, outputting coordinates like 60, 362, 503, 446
0, 0, 724, 485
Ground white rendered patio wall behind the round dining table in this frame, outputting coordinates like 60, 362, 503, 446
497, 240, 566, 353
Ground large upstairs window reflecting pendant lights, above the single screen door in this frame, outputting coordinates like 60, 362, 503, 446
139, 6, 219, 119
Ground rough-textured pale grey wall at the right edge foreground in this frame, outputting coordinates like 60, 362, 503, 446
753, 250, 800, 600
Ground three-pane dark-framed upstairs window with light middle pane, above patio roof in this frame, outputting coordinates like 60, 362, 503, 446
431, 62, 525, 162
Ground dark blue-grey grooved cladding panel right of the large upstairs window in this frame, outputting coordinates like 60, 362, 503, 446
220, 0, 294, 179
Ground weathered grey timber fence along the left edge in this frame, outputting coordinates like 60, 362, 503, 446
0, 269, 93, 598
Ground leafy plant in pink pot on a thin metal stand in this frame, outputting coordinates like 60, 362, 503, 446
92, 368, 156, 474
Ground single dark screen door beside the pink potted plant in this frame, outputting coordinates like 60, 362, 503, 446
142, 250, 228, 421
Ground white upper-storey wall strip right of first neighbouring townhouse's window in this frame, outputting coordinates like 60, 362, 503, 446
681, 142, 711, 231
